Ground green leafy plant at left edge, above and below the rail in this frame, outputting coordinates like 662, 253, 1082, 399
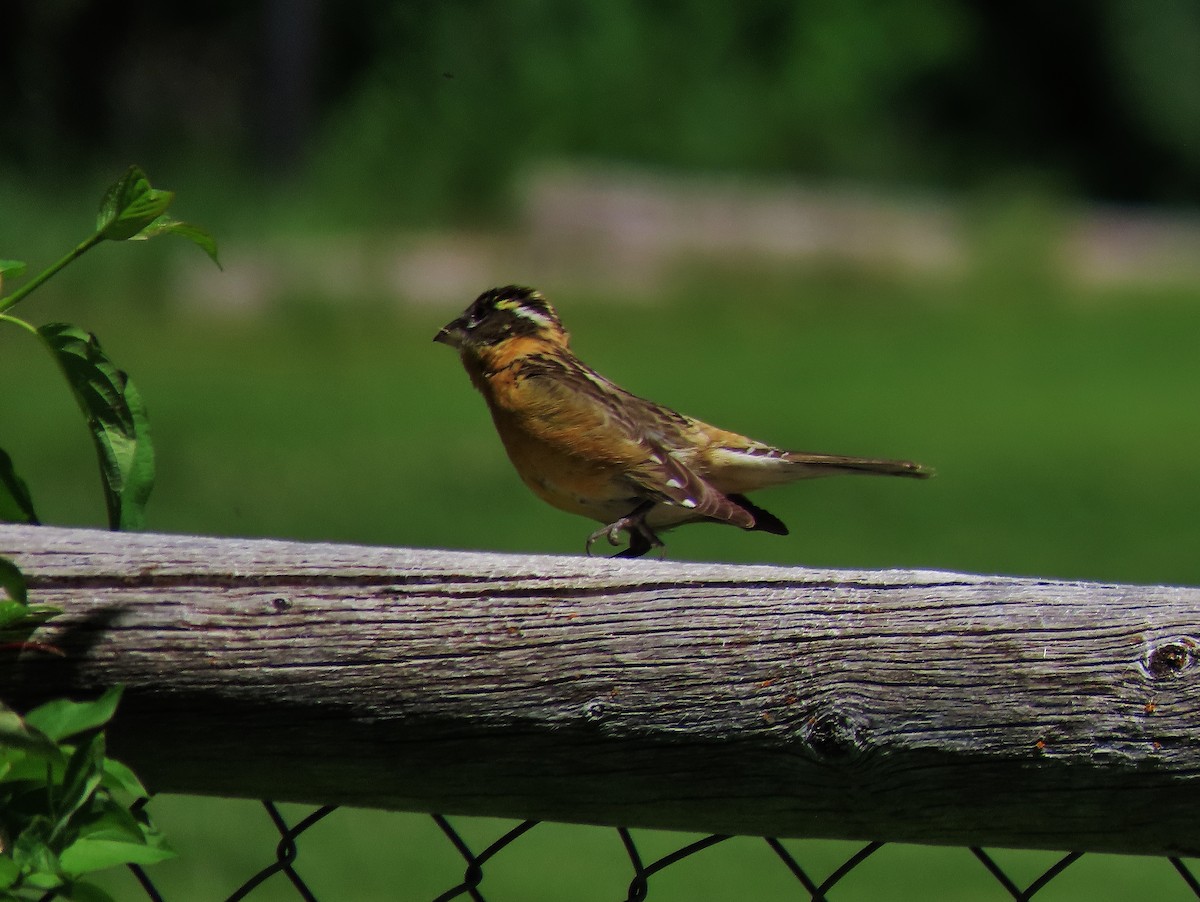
0, 167, 217, 902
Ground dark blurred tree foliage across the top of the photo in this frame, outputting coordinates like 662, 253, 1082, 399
0, 0, 1200, 221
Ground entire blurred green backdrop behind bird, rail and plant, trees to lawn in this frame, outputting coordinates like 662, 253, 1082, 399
0, 0, 1200, 900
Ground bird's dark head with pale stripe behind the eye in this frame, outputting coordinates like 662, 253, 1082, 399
433, 285, 566, 351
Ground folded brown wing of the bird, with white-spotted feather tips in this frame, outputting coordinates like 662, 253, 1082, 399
517, 355, 755, 529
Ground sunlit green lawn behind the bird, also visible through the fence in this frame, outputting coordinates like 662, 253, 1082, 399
0, 259, 1200, 902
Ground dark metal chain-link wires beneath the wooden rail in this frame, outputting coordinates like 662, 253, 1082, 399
70, 800, 1200, 902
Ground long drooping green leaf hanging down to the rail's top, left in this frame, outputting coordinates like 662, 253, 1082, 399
37, 323, 154, 529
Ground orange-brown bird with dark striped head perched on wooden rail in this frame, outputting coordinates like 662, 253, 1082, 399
433, 285, 932, 558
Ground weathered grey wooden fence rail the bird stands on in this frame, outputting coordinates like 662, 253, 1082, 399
0, 527, 1200, 855
